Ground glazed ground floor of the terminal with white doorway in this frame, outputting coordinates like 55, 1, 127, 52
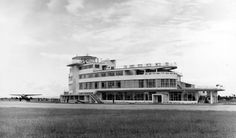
61, 91, 218, 104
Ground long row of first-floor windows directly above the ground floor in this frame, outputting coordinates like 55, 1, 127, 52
79, 79, 176, 89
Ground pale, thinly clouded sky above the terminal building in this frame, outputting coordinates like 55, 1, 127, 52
0, 0, 236, 97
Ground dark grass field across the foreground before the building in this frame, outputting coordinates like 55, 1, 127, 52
0, 108, 236, 138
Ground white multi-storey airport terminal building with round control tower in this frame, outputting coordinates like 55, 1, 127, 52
60, 56, 223, 104
